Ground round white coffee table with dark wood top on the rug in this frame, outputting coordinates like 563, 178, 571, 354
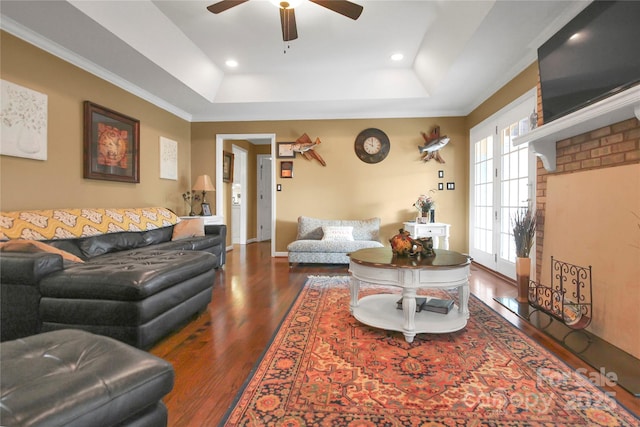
349, 247, 471, 342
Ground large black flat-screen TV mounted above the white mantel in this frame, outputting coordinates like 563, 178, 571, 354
538, 1, 640, 123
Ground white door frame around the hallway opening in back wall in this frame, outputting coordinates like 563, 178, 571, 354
215, 133, 276, 257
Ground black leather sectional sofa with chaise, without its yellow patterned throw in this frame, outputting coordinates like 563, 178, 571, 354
0, 209, 226, 349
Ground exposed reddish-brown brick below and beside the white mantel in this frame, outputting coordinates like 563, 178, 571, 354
536, 83, 640, 278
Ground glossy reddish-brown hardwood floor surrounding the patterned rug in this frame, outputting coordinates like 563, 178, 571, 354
151, 242, 640, 427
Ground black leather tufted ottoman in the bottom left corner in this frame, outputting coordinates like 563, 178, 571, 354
0, 329, 174, 427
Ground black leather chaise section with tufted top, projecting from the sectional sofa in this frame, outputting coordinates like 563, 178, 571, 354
40, 249, 218, 349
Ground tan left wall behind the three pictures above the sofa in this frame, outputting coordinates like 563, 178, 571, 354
0, 32, 191, 214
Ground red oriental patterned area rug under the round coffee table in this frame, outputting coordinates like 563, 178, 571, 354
223, 276, 639, 427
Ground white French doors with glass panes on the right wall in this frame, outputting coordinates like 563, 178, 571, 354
469, 89, 536, 278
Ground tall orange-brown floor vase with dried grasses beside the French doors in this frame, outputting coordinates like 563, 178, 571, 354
513, 207, 536, 302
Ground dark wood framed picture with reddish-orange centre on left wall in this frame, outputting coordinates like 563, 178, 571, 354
83, 101, 140, 183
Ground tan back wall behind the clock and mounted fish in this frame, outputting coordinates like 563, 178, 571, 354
192, 117, 468, 252
